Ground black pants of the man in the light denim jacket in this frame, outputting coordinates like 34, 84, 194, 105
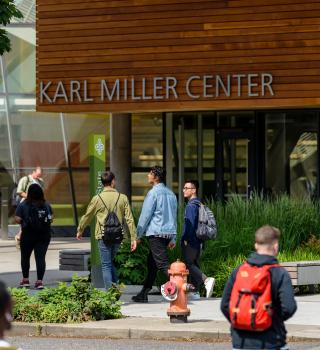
143, 236, 170, 289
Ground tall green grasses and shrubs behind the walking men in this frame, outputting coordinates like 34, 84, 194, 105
116, 195, 320, 296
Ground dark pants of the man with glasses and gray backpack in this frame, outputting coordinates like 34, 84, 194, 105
182, 244, 207, 290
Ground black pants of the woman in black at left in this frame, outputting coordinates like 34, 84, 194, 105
20, 233, 50, 280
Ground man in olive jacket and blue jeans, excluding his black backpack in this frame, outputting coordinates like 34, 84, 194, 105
77, 171, 137, 290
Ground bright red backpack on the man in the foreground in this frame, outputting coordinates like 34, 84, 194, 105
229, 262, 280, 331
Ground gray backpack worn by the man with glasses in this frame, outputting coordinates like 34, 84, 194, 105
196, 204, 218, 241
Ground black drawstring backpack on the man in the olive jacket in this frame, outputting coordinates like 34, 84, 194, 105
98, 193, 123, 246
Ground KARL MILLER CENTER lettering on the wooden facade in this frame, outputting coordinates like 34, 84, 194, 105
38, 73, 275, 104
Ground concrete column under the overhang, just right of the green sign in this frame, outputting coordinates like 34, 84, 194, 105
110, 114, 131, 200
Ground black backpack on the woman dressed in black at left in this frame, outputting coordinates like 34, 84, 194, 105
27, 204, 52, 233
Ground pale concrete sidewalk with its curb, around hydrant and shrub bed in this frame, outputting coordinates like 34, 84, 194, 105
0, 238, 320, 341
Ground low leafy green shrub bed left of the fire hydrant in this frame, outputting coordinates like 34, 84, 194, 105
10, 276, 122, 323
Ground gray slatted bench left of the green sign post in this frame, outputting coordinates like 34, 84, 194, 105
59, 249, 90, 271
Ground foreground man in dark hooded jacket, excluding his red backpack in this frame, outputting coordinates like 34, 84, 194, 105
220, 225, 297, 350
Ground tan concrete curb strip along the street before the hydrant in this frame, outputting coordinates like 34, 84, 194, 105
8, 317, 320, 342
